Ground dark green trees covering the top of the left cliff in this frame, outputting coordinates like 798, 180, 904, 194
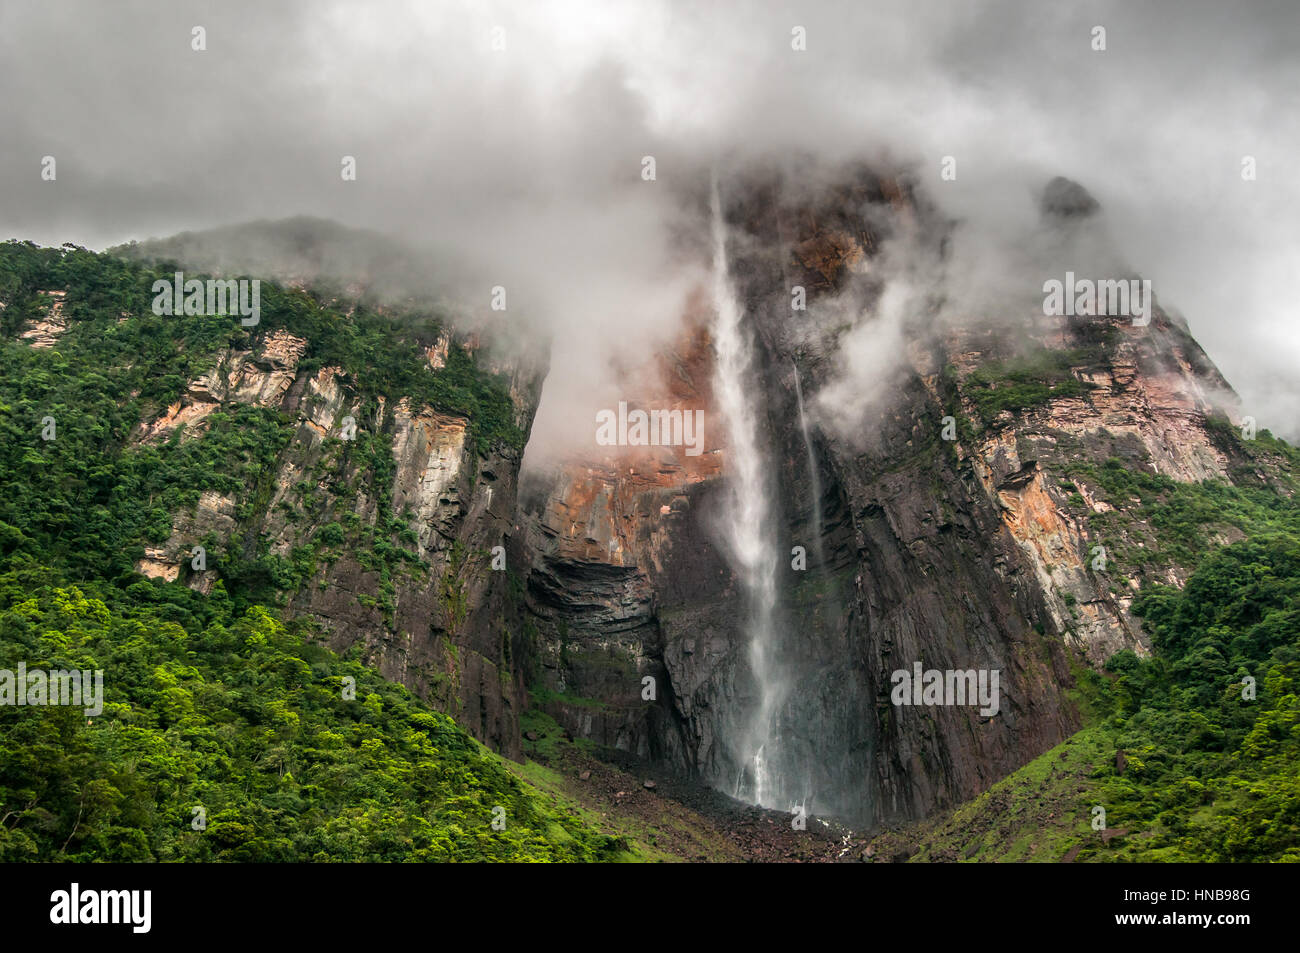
0, 242, 524, 454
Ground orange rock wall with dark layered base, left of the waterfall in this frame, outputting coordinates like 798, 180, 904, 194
520, 312, 735, 770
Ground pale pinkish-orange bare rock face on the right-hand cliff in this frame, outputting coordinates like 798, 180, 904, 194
953, 312, 1232, 664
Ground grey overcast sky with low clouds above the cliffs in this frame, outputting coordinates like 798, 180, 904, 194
0, 0, 1300, 437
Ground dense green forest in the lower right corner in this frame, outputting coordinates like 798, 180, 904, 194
1096, 502, 1300, 862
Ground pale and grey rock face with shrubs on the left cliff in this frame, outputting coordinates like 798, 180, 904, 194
133, 330, 542, 757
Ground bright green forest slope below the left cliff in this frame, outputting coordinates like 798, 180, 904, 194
0, 572, 625, 861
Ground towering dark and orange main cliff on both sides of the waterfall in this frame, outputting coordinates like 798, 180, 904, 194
509, 163, 1248, 826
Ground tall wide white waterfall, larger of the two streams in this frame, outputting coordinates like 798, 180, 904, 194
710, 177, 784, 807
